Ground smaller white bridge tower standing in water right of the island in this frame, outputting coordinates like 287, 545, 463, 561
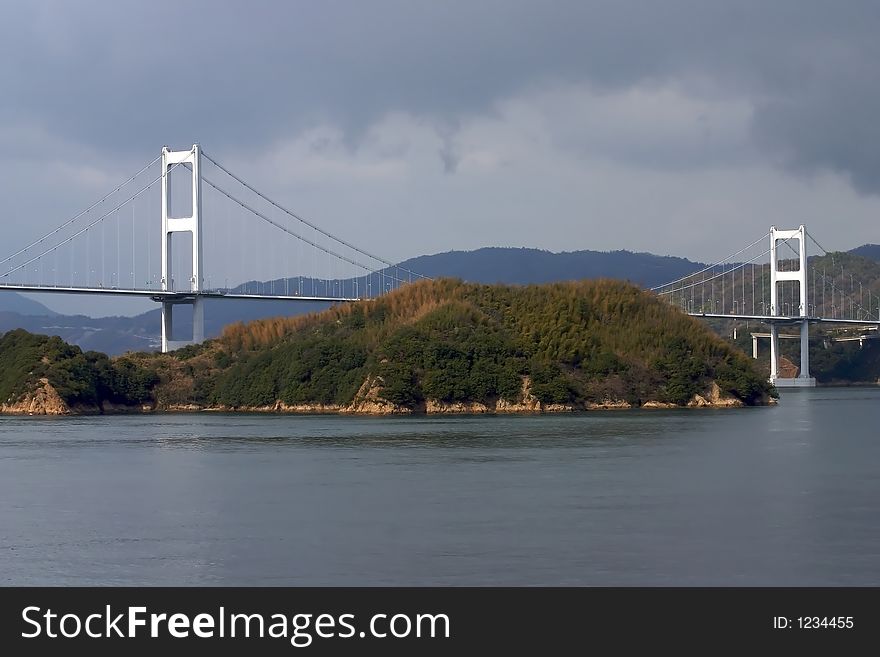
770, 224, 816, 388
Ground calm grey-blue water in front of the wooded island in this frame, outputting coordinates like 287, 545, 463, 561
0, 388, 880, 585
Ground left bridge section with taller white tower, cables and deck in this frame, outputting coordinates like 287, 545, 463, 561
0, 144, 426, 352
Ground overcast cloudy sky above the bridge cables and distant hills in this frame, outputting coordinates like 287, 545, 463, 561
0, 0, 880, 313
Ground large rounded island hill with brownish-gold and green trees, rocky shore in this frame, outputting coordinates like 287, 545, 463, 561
115, 279, 772, 413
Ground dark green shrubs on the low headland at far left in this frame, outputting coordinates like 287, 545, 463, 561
0, 329, 158, 406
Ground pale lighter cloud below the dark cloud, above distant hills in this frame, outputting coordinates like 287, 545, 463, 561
199, 79, 880, 266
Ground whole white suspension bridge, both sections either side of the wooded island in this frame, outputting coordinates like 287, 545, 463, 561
0, 144, 880, 386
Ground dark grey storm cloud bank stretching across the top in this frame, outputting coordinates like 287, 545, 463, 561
0, 0, 880, 192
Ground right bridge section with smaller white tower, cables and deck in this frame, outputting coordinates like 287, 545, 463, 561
651, 225, 880, 387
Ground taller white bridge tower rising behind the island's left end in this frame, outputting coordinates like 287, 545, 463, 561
162, 144, 205, 353
